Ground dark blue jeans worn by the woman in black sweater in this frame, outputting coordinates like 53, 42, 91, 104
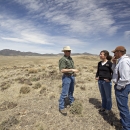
98, 80, 112, 110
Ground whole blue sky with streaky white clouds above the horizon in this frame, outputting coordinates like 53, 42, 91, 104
0, 0, 130, 54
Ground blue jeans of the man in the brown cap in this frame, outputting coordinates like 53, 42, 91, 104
114, 84, 130, 130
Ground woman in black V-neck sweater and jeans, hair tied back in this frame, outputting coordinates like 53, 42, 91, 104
96, 50, 112, 114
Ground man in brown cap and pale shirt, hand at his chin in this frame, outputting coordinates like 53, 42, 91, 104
112, 46, 130, 130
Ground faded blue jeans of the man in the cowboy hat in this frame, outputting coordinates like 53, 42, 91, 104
59, 75, 75, 109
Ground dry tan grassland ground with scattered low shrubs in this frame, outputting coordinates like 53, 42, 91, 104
0, 55, 130, 130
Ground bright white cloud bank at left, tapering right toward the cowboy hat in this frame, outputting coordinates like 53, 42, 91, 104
0, 9, 88, 45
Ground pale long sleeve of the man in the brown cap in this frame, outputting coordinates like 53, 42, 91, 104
117, 61, 130, 88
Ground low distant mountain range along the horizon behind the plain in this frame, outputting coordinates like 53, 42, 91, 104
0, 49, 93, 56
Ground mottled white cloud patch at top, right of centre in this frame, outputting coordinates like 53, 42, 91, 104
44, 0, 118, 35
